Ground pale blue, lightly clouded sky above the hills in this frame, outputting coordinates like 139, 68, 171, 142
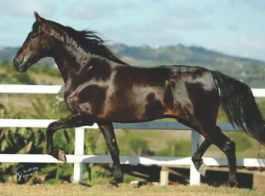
0, 0, 265, 60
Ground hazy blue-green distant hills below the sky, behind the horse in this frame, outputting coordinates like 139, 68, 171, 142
0, 44, 265, 87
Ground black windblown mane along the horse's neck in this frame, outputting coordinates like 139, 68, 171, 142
43, 20, 128, 65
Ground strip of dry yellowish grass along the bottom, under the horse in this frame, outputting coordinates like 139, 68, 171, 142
0, 184, 265, 196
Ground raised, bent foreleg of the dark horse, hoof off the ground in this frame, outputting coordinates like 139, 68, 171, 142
47, 115, 93, 161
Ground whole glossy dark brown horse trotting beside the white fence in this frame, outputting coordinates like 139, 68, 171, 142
14, 13, 265, 185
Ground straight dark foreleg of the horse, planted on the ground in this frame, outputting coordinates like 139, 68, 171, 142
98, 123, 123, 183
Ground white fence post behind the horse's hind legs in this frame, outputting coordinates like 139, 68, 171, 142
190, 130, 202, 185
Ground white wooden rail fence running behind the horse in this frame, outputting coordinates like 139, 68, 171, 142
0, 85, 265, 185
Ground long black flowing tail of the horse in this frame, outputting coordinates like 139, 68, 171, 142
212, 71, 265, 144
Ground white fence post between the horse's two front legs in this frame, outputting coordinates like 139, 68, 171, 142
73, 127, 85, 183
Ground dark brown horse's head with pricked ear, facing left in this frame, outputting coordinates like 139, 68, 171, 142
13, 12, 53, 72
